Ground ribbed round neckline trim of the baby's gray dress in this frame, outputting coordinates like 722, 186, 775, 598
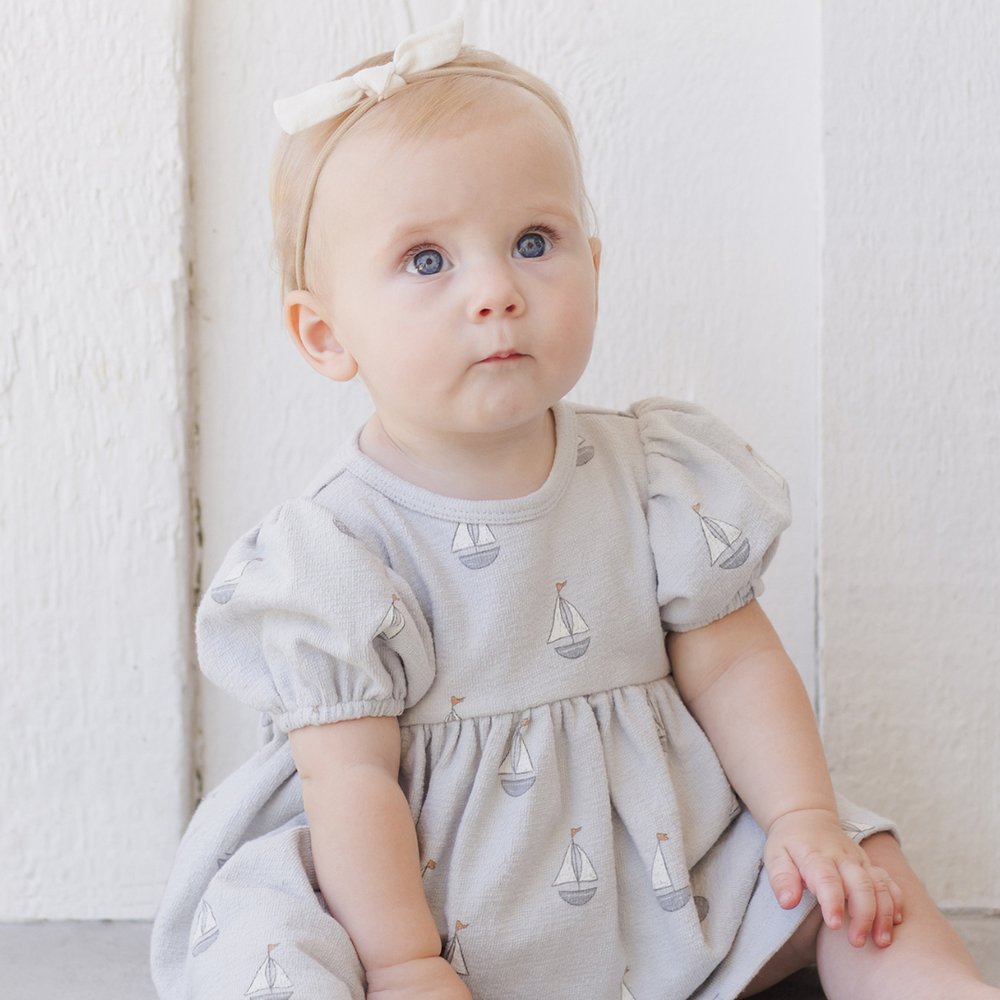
344, 400, 576, 524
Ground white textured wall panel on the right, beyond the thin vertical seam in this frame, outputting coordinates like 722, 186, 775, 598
821, 0, 1000, 907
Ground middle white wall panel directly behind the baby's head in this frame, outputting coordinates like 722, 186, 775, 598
193, 0, 820, 788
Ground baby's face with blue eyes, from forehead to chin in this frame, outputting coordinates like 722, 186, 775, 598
298, 94, 599, 446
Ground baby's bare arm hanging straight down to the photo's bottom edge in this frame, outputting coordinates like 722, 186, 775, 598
288, 717, 469, 1000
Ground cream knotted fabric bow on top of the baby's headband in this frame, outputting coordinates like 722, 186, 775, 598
274, 17, 464, 135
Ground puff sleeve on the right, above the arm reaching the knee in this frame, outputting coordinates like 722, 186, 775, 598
632, 399, 791, 632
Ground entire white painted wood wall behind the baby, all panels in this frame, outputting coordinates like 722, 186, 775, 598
0, 0, 1000, 919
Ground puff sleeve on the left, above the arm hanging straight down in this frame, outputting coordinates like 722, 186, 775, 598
197, 499, 434, 732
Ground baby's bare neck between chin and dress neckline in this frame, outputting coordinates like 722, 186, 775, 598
358, 410, 556, 500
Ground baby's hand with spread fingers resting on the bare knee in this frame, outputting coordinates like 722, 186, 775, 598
764, 809, 903, 948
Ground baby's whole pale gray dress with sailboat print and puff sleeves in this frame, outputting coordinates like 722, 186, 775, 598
153, 399, 891, 1000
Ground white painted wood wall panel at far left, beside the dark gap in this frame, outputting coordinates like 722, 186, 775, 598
0, 0, 190, 920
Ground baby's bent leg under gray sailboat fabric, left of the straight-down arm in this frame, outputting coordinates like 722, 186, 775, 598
183, 817, 365, 1000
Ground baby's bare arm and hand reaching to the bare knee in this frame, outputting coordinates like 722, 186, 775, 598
667, 601, 902, 947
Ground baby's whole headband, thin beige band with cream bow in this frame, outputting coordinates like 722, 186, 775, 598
274, 17, 572, 289
